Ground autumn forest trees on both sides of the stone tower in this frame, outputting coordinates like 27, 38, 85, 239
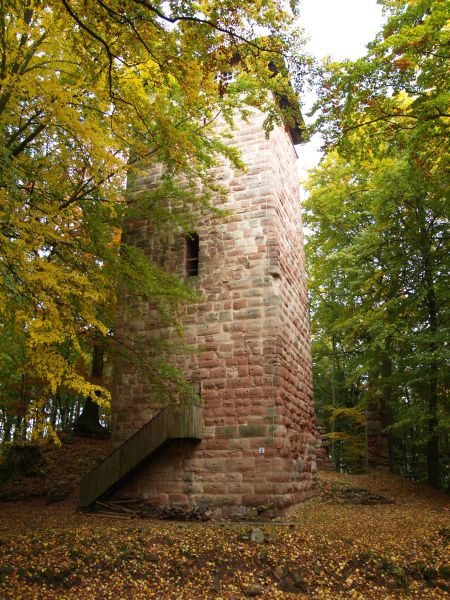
0, 0, 450, 487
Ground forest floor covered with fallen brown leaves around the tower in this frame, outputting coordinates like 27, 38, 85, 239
0, 439, 450, 600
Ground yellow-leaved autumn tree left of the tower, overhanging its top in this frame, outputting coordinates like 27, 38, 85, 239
0, 0, 308, 440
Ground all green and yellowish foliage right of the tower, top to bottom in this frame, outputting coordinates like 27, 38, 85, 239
305, 0, 450, 486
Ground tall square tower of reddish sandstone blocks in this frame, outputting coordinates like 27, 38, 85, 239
112, 106, 316, 515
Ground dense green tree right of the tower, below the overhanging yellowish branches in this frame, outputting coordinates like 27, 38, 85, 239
305, 145, 449, 486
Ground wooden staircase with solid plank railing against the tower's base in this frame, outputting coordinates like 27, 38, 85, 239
80, 404, 203, 508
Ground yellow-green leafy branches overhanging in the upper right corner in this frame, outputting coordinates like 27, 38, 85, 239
316, 0, 450, 157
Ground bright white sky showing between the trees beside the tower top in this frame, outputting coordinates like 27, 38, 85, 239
298, 0, 383, 179
